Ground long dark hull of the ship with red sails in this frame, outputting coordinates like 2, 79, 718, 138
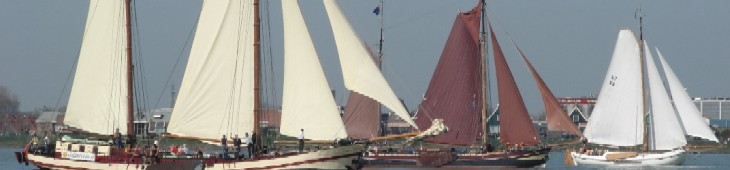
362, 148, 550, 168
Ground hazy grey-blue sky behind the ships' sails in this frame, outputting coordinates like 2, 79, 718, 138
0, 0, 730, 114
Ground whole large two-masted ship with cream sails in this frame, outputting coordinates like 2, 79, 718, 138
19, 0, 404, 169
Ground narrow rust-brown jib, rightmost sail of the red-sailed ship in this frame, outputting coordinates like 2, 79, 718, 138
512, 41, 583, 137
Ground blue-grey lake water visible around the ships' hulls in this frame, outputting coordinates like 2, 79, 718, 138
0, 148, 730, 170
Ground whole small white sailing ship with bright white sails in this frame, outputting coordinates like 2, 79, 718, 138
570, 29, 718, 165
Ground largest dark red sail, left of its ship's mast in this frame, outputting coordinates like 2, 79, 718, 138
416, 6, 484, 145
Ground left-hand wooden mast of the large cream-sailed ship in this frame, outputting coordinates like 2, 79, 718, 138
124, 0, 137, 146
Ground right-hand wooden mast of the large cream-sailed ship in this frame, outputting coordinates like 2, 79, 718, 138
253, 0, 262, 147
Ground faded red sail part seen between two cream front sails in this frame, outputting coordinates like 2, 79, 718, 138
342, 91, 380, 139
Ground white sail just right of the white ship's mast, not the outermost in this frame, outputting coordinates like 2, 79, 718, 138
644, 41, 687, 150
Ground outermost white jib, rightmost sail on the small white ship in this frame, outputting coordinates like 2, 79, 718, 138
656, 48, 718, 142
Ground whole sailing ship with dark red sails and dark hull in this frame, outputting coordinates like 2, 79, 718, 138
363, 1, 582, 167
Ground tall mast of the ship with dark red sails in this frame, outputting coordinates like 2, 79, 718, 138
479, 0, 489, 145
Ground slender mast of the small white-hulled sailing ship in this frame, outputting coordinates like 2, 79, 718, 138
637, 7, 649, 151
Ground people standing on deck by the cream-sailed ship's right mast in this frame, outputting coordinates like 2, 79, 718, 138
220, 133, 258, 160
